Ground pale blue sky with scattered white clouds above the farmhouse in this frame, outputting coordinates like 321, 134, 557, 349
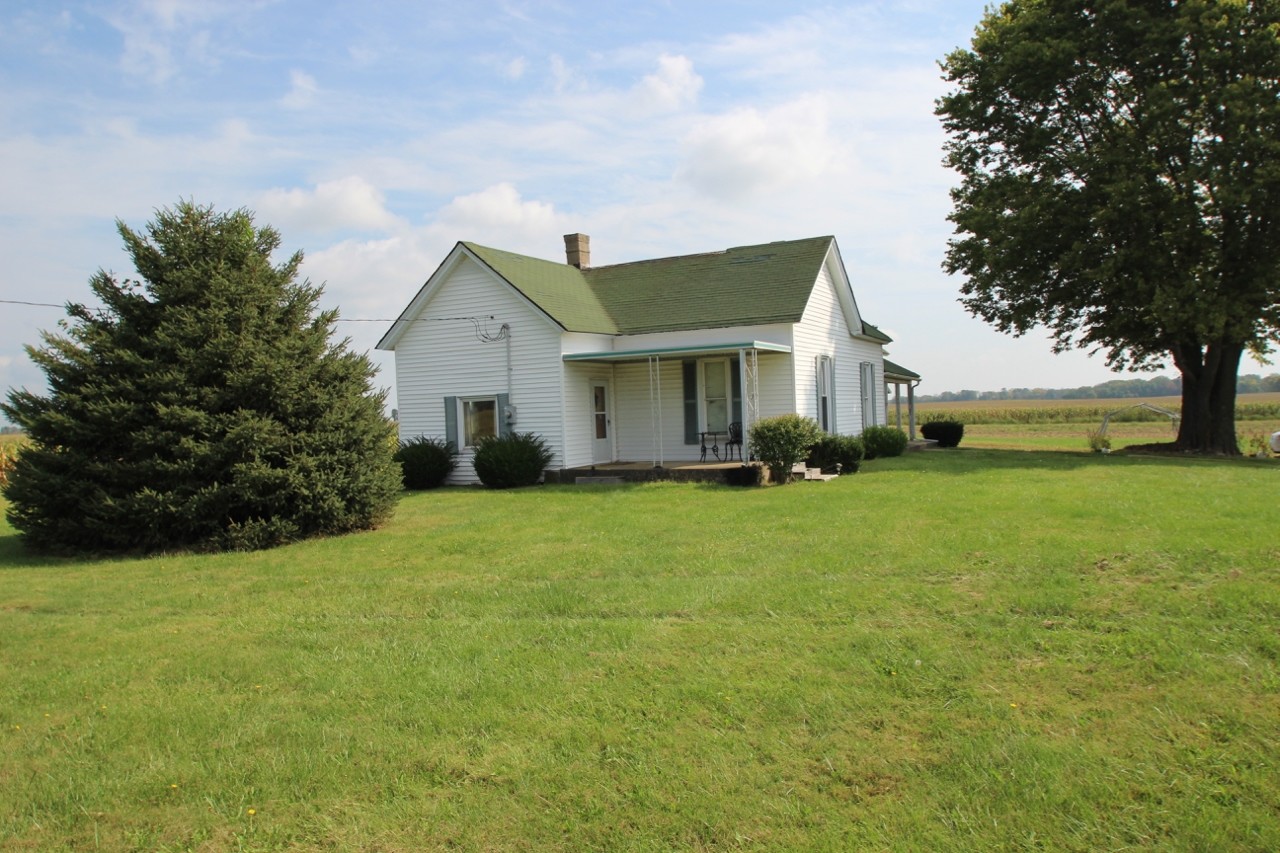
0, 0, 1203, 412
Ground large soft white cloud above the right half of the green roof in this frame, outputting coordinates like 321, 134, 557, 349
677, 96, 838, 201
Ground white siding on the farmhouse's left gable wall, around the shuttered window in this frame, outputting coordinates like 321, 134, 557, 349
396, 259, 564, 483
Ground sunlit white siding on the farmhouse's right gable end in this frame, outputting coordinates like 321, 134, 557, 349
795, 265, 884, 435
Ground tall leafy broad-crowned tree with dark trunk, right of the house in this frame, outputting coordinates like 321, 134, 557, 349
938, 0, 1280, 455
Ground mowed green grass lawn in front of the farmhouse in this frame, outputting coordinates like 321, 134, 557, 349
0, 447, 1280, 850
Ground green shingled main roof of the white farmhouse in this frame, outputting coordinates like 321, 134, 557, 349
463, 237, 870, 341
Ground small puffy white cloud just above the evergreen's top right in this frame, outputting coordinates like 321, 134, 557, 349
257, 175, 402, 233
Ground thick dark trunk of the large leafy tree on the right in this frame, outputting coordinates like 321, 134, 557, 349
1171, 343, 1244, 456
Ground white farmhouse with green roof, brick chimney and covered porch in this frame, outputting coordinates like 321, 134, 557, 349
378, 234, 919, 483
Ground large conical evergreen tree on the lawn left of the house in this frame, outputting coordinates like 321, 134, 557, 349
0, 202, 399, 552
